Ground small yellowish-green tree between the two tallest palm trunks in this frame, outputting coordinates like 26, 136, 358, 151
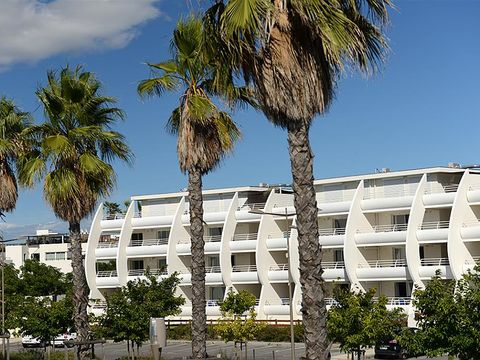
215, 290, 265, 347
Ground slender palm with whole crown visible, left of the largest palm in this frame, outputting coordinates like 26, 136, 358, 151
138, 17, 244, 359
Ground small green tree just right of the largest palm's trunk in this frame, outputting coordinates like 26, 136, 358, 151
327, 288, 406, 359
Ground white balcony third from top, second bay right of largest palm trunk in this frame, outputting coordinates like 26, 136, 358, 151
357, 259, 408, 281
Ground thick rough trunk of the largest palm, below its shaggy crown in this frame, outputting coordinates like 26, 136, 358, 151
288, 122, 328, 360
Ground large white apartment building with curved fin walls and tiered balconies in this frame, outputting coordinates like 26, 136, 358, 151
86, 164, 480, 320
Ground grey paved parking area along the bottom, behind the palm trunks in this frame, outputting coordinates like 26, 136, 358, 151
5, 340, 448, 360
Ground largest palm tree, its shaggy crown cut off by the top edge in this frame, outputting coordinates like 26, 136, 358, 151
205, 0, 391, 359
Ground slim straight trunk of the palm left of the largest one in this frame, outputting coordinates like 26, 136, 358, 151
188, 168, 207, 359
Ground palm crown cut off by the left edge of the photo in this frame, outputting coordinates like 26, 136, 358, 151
0, 97, 30, 217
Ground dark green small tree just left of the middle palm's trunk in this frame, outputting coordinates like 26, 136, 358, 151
99, 273, 185, 358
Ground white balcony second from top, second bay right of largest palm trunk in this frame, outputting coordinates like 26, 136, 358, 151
355, 224, 408, 246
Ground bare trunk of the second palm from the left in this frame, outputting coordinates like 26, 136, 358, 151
69, 222, 90, 360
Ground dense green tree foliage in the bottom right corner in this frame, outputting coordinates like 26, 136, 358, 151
402, 267, 480, 360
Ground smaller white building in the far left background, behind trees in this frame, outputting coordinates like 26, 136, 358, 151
5, 230, 87, 273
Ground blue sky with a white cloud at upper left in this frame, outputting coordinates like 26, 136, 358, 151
0, 0, 480, 238
